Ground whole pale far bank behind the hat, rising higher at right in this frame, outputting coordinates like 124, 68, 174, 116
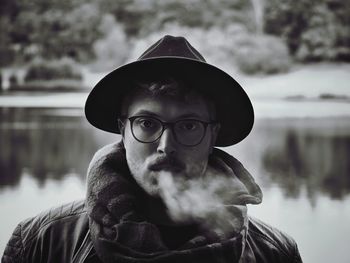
0, 63, 350, 119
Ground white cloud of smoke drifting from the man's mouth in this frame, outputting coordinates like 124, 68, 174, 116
158, 169, 252, 239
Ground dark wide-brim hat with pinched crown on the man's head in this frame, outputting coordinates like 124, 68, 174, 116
85, 36, 254, 146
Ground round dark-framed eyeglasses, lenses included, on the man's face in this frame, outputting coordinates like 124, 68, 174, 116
128, 116, 215, 146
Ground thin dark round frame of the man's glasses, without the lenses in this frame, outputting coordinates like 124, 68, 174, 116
124, 115, 218, 147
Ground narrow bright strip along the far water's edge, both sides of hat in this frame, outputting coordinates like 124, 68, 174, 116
0, 92, 350, 119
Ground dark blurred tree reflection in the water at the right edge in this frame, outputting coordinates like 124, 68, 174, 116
262, 120, 350, 203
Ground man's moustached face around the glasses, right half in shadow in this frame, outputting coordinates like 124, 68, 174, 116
121, 94, 219, 196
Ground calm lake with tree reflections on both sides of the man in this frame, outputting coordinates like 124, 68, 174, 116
0, 108, 350, 263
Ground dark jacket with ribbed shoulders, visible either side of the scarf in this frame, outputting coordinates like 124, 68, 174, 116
2, 201, 301, 263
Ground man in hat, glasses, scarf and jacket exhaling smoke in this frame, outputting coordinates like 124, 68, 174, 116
3, 36, 301, 262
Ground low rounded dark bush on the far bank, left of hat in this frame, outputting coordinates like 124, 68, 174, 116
24, 59, 82, 82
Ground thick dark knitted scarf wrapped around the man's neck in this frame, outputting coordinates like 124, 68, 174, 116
86, 143, 262, 263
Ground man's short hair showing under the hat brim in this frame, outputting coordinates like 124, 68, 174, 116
121, 77, 216, 120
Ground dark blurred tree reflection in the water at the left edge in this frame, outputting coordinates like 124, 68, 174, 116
0, 109, 115, 187
